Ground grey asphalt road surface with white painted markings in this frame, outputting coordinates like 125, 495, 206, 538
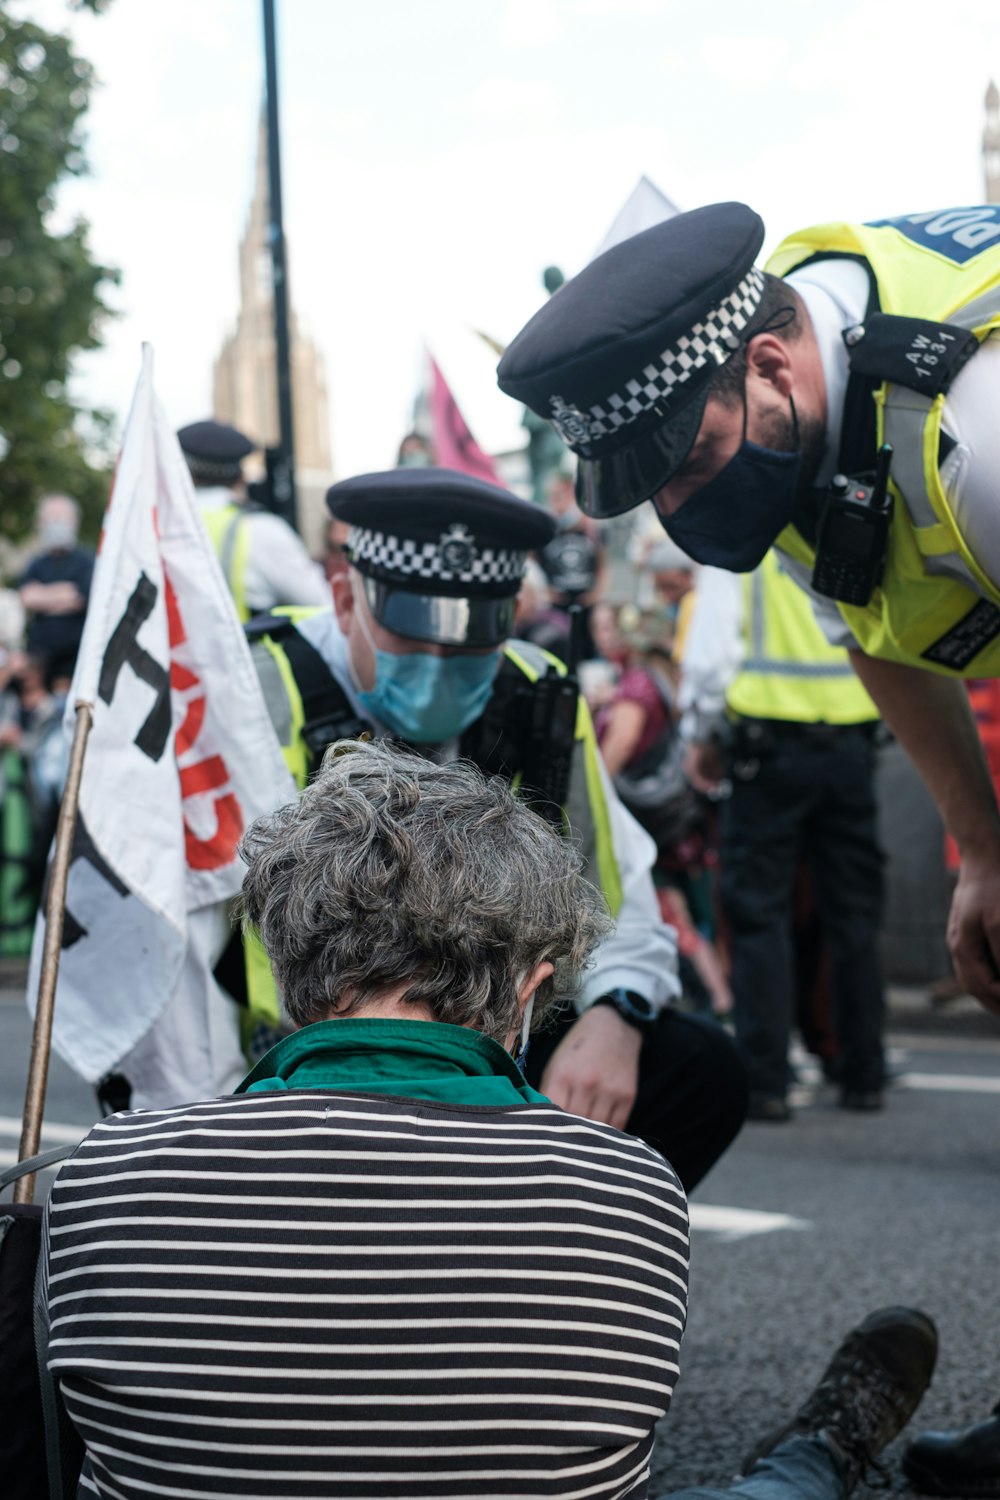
0, 969, 1000, 1497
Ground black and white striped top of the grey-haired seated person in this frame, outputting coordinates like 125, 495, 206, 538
48, 1089, 688, 1500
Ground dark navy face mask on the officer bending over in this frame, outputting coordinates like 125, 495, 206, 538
660, 404, 802, 573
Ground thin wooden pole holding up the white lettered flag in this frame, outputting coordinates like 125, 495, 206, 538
13, 701, 94, 1203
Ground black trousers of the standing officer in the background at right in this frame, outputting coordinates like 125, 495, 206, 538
721, 726, 885, 1097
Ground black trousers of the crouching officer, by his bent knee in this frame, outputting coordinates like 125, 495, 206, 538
525, 1011, 747, 1193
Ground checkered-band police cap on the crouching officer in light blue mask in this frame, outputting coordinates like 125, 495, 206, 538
327, 468, 555, 647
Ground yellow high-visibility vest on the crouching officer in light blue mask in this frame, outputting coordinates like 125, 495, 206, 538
243, 606, 622, 1023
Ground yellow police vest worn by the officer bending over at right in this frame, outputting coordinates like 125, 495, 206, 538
766, 206, 1000, 677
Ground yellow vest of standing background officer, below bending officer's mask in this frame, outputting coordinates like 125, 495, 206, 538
726, 552, 879, 725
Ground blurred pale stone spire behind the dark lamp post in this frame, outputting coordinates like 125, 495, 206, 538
213, 110, 333, 555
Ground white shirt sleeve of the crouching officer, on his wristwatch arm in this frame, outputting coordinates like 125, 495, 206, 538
576, 762, 681, 1013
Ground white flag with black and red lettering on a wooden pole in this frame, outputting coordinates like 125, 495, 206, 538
28, 348, 295, 1083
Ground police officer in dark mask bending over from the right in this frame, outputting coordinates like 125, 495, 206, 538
499, 203, 1000, 1020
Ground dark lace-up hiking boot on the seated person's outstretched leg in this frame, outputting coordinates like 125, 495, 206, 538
741, 1308, 937, 1490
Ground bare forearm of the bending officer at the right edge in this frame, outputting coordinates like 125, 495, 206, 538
850, 651, 1000, 1011
